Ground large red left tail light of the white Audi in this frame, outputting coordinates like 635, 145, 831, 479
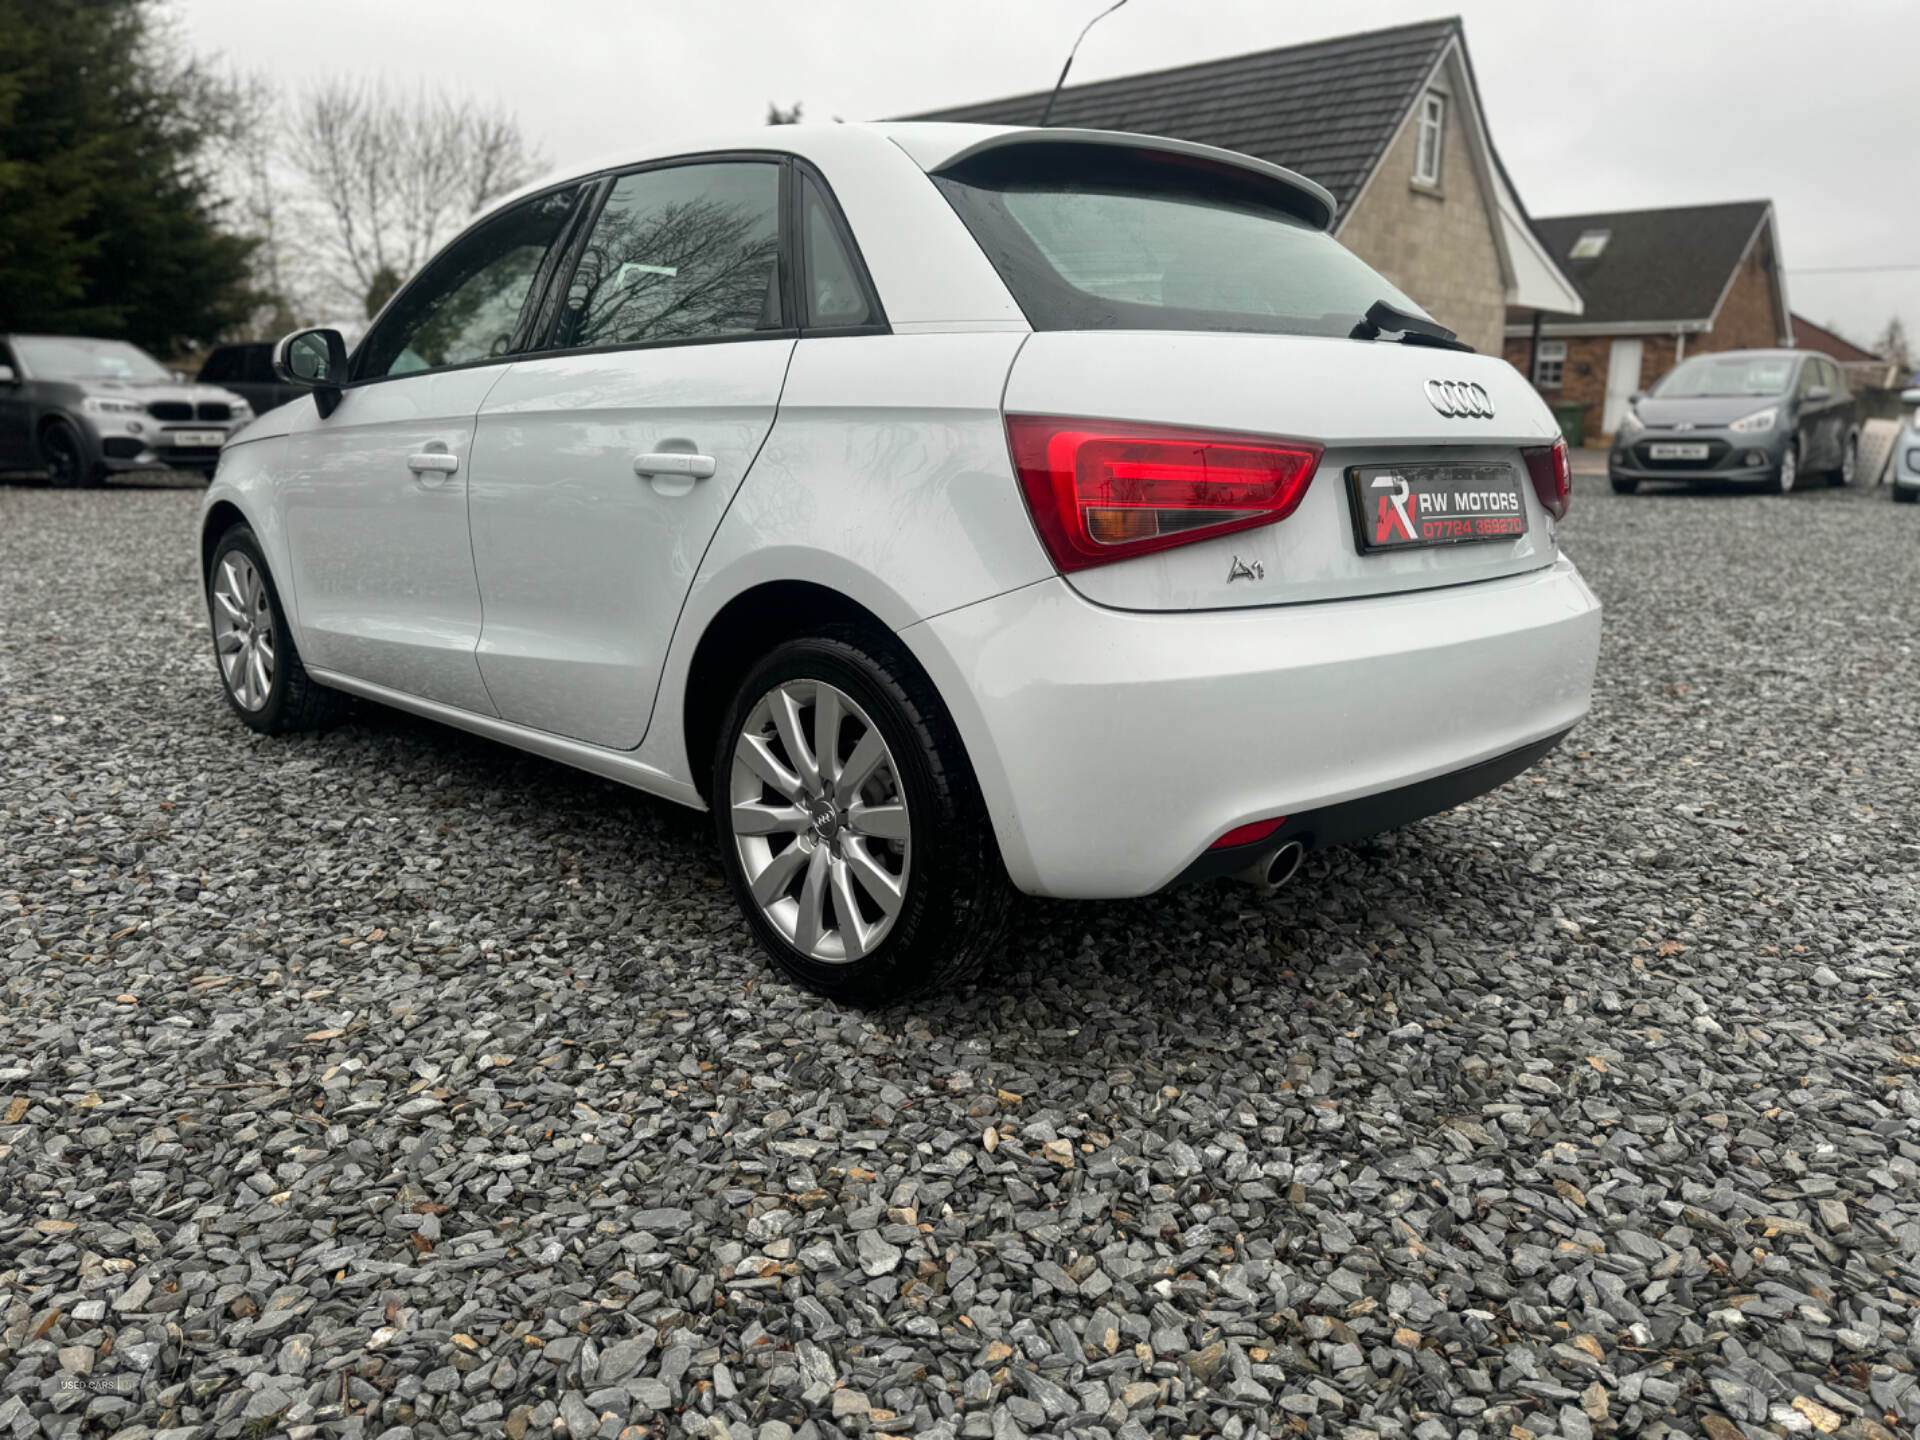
1006, 415, 1321, 570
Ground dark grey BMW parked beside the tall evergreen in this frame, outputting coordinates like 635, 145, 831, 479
0, 334, 253, 486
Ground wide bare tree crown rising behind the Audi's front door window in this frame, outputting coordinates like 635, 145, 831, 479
286, 81, 545, 309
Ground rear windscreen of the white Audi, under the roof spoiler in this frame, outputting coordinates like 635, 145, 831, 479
935, 144, 1427, 336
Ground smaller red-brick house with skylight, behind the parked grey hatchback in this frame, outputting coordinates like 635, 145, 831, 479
1505, 200, 1793, 445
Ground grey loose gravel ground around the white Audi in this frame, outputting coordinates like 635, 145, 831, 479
0, 480, 1920, 1440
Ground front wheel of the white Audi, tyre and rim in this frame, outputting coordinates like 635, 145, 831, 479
207, 524, 346, 735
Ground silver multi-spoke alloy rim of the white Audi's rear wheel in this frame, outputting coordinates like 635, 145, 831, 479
728, 680, 912, 964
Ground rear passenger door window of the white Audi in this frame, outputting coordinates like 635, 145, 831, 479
555, 161, 783, 349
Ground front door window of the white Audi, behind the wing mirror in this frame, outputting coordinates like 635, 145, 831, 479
355, 188, 578, 380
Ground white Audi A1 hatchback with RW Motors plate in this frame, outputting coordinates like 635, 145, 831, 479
202, 125, 1599, 1004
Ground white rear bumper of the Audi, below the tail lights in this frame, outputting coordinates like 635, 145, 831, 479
902, 559, 1599, 899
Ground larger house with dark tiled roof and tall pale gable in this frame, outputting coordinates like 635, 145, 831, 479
908, 17, 1582, 355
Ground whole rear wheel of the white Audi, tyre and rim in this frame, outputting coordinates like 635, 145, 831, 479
710, 630, 1014, 1006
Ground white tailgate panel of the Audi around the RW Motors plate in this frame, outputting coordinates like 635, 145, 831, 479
1006, 330, 1559, 611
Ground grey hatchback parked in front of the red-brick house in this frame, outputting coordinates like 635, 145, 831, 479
1607, 349, 1860, 495
